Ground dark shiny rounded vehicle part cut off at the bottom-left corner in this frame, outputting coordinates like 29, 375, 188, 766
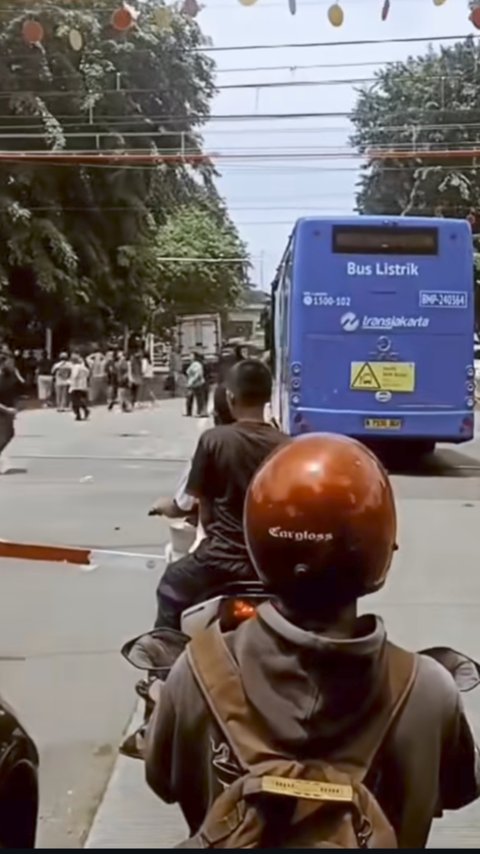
0, 699, 39, 849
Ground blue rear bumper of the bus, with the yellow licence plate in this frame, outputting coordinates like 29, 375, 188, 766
290, 407, 475, 444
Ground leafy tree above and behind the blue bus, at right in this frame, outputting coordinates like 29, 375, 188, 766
352, 37, 480, 219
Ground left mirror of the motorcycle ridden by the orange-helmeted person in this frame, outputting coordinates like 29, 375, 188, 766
121, 629, 190, 672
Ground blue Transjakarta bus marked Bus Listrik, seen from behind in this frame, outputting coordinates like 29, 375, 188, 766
272, 216, 475, 453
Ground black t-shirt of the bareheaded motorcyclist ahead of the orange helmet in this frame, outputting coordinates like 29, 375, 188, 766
187, 421, 288, 561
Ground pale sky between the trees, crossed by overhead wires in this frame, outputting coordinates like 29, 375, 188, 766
190, 0, 478, 289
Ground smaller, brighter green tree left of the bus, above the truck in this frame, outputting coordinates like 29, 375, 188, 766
127, 203, 248, 338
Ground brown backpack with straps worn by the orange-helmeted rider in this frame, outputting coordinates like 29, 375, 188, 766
177, 624, 416, 848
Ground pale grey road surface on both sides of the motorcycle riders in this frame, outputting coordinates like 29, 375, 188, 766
0, 401, 480, 848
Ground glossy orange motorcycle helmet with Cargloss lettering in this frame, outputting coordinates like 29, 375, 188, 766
244, 433, 397, 611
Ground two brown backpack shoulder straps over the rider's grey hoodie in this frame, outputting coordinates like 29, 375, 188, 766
187, 622, 417, 781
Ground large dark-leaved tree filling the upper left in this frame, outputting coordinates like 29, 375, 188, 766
0, 0, 248, 348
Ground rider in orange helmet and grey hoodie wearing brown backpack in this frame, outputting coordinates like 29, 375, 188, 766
145, 434, 479, 848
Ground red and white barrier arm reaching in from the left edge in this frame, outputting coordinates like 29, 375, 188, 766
0, 540, 165, 572
